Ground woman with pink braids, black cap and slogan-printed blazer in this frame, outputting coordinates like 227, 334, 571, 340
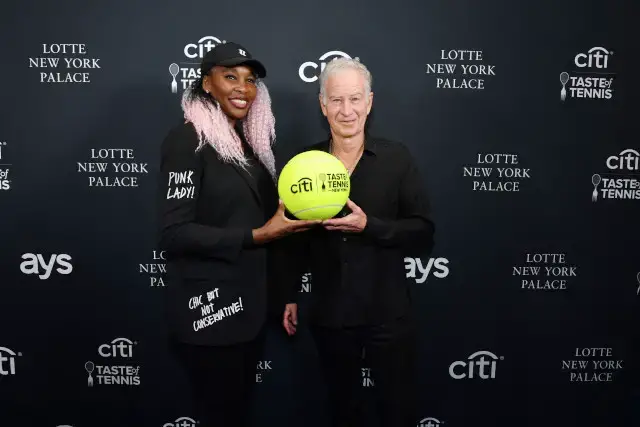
160, 43, 316, 427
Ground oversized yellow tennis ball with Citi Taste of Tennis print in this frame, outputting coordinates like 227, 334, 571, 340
278, 150, 351, 219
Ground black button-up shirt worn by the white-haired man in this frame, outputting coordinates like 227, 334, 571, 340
286, 137, 434, 327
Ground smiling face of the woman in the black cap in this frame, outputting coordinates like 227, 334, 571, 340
202, 65, 257, 120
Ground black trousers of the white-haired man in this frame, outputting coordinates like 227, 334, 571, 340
310, 316, 418, 427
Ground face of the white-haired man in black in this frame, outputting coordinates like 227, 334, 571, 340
320, 69, 373, 138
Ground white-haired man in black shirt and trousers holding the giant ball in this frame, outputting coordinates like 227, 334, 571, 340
283, 58, 434, 427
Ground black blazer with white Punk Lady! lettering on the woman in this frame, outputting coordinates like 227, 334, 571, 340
159, 123, 278, 345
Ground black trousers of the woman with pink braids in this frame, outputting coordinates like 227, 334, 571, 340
171, 331, 265, 427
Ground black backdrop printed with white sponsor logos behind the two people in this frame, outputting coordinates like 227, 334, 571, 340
0, 0, 640, 427
